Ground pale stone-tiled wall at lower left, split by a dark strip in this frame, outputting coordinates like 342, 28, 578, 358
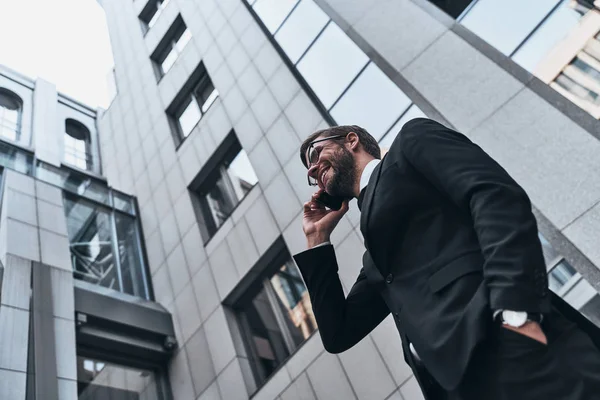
0, 170, 77, 400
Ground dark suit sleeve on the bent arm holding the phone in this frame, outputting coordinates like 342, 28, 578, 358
294, 245, 390, 353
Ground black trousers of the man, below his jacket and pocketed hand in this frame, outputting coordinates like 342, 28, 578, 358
420, 315, 600, 400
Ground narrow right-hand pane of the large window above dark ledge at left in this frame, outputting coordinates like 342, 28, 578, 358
115, 213, 147, 298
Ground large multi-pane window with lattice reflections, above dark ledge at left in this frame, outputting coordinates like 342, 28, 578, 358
63, 183, 149, 299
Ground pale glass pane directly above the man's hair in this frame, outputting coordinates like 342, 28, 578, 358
331, 63, 410, 140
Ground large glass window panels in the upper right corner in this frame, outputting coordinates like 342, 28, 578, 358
459, 0, 600, 118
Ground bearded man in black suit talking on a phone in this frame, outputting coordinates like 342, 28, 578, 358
294, 118, 600, 400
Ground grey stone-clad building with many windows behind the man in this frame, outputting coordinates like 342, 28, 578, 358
0, 0, 600, 400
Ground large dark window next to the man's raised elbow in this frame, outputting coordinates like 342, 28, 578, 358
232, 248, 317, 386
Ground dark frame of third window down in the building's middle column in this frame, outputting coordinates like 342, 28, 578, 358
166, 62, 220, 145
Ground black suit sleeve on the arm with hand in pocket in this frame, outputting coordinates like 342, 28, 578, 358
399, 119, 550, 313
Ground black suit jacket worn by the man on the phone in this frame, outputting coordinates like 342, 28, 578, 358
294, 118, 594, 390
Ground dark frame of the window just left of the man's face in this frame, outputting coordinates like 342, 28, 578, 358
188, 130, 258, 246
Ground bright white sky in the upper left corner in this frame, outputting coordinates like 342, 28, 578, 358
0, 0, 113, 108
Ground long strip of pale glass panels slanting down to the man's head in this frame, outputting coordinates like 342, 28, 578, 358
247, 0, 424, 147
